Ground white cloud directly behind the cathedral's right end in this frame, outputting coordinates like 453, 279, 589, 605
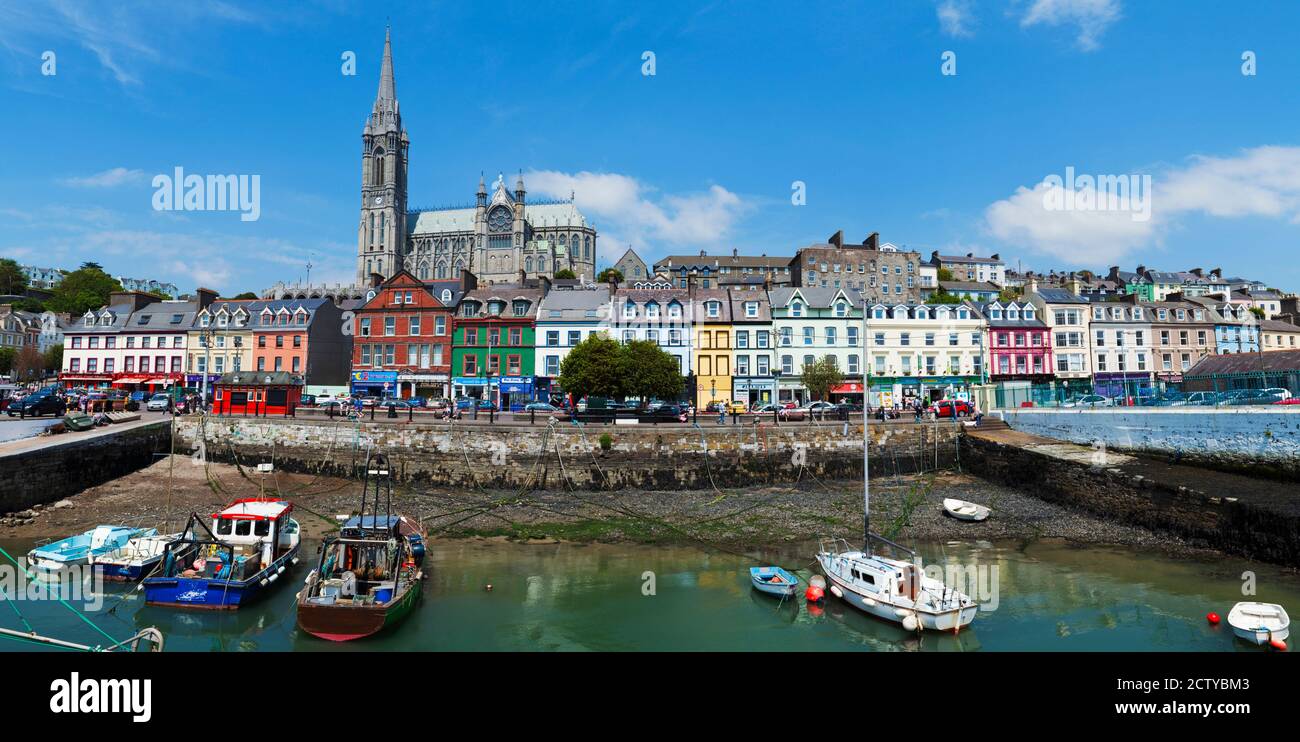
524, 170, 750, 260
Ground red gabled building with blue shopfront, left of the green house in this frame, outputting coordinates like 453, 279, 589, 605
351, 270, 472, 399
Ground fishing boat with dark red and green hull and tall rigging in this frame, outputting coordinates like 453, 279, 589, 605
298, 454, 425, 642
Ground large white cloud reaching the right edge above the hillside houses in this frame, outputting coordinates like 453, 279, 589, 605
984, 146, 1300, 264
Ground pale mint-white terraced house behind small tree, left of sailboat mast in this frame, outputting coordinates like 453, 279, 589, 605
767, 286, 863, 403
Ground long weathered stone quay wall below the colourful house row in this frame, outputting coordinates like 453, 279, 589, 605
177, 417, 961, 490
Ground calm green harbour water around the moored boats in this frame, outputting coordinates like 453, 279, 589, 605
0, 539, 1300, 651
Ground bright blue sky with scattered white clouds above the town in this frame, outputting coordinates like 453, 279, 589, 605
0, 0, 1300, 294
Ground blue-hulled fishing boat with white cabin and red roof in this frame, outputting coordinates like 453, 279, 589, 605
142, 496, 302, 611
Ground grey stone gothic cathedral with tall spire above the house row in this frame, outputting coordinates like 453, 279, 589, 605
356, 26, 595, 287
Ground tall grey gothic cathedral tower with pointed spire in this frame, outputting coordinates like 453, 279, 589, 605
356, 31, 411, 286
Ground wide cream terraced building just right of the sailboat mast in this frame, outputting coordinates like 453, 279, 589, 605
866, 303, 985, 407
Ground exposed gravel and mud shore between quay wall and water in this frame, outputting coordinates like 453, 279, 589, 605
0, 456, 1213, 563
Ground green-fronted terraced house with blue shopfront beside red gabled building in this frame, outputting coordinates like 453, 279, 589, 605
451, 278, 549, 409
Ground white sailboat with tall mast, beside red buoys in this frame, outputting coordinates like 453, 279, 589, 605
816, 298, 979, 633
